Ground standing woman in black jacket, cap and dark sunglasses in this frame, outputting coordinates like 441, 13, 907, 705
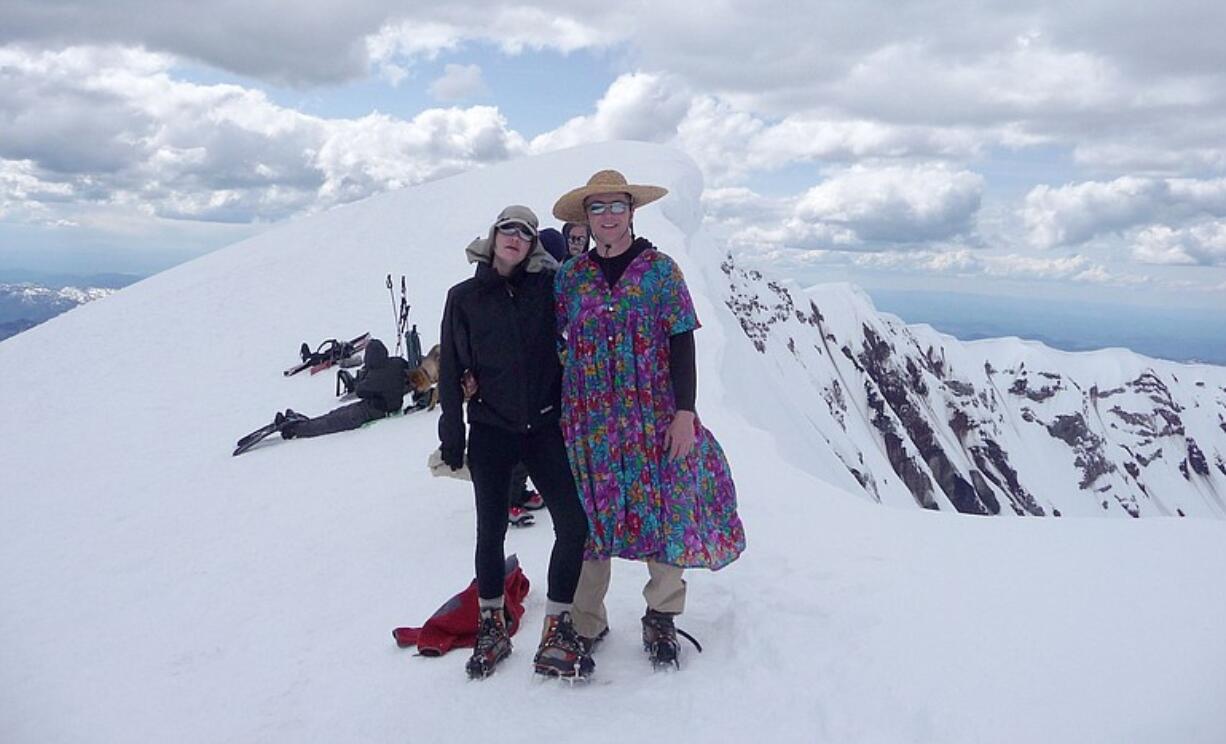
439, 206, 593, 678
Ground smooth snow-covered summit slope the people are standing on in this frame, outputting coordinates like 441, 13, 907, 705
0, 143, 1226, 744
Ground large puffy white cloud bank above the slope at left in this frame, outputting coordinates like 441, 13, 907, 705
0, 47, 525, 222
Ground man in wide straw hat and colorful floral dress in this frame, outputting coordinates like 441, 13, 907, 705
553, 170, 745, 666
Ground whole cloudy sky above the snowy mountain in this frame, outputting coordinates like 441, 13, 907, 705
0, 0, 1226, 311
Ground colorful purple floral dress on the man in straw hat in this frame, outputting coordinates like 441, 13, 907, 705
555, 245, 745, 569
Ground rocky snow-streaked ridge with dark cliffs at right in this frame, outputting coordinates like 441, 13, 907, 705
722, 259, 1226, 518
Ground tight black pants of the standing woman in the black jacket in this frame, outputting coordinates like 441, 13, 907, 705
468, 424, 587, 604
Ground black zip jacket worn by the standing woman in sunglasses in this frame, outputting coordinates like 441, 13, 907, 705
439, 262, 562, 463
